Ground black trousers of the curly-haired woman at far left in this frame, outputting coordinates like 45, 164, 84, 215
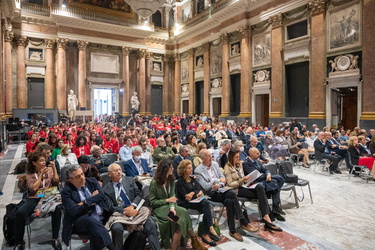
14, 198, 62, 245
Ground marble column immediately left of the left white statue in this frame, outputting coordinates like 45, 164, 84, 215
56, 38, 69, 112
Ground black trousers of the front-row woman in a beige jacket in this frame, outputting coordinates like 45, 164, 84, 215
238, 184, 271, 217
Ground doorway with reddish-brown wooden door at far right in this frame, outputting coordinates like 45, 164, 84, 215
331, 87, 358, 130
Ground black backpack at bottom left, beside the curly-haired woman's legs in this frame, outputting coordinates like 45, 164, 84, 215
3, 200, 25, 247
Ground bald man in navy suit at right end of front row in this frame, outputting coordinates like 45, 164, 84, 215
242, 148, 285, 221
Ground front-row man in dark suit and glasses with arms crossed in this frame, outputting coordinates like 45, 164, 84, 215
61, 165, 115, 250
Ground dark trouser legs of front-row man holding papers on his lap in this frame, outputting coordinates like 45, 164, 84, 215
111, 217, 160, 250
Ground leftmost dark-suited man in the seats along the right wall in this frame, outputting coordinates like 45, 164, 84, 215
314, 132, 341, 174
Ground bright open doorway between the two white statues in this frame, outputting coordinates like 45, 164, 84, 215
93, 88, 118, 118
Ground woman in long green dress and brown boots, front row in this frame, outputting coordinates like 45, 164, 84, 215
150, 159, 207, 250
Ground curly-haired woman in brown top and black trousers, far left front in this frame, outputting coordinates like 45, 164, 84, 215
14, 152, 62, 250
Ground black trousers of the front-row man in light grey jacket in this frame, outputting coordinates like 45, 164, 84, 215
209, 190, 248, 233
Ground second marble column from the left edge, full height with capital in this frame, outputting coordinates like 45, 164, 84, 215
17, 37, 28, 109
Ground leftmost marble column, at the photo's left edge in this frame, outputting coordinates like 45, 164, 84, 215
4, 30, 14, 117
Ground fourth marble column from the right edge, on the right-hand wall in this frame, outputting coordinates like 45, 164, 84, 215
238, 26, 252, 118
